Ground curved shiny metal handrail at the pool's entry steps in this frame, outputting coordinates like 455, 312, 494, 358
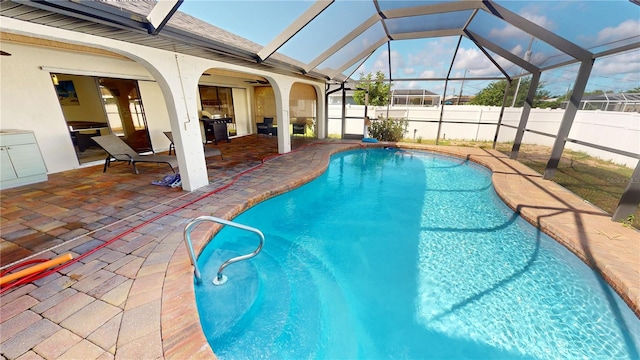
184, 216, 264, 285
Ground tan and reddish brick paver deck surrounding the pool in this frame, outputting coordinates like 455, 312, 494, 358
0, 136, 640, 359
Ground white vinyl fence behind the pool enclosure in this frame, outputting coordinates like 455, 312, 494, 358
328, 105, 640, 168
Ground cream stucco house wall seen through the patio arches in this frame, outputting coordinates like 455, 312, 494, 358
0, 42, 328, 173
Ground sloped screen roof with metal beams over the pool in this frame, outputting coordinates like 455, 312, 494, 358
174, 0, 640, 94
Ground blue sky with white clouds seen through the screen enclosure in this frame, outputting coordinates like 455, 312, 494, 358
179, 0, 640, 95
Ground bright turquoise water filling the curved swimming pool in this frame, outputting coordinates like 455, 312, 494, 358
196, 149, 640, 359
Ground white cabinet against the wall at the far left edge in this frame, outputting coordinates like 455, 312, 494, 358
0, 130, 47, 189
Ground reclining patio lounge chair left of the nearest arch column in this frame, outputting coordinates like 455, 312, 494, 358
92, 134, 178, 174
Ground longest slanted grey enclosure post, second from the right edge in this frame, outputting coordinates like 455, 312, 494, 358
543, 59, 593, 180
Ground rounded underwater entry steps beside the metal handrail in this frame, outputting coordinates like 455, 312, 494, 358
199, 234, 357, 358
